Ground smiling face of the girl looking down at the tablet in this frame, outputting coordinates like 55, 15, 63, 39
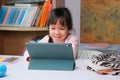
49, 20, 69, 43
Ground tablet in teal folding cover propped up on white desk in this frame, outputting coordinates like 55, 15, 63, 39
26, 42, 75, 70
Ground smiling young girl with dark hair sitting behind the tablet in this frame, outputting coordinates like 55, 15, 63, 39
25, 8, 79, 59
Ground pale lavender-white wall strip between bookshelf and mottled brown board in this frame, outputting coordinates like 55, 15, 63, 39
65, 0, 81, 40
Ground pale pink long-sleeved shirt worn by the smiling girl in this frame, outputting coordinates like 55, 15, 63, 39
24, 35, 79, 60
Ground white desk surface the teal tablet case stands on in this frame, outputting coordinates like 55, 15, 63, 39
0, 57, 120, 80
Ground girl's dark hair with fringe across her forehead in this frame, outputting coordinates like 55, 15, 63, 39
46, 7, 73, 30
